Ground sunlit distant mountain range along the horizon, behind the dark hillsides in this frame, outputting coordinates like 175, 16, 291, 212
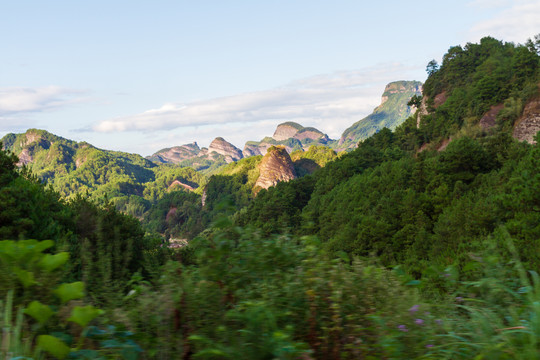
0, 81, 421, 201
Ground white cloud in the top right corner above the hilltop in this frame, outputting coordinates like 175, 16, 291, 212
470, 0, 540, 43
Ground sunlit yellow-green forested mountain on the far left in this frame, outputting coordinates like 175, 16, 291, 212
0, 129, 206, 210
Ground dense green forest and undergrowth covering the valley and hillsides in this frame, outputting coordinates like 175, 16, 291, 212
0, 35, 540, 359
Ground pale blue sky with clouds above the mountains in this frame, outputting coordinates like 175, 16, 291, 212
0, 0, 540, 156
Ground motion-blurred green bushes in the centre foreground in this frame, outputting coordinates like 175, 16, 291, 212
121, 219, 422, 359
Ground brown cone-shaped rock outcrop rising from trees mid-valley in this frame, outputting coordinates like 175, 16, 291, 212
255, 146, 296, 189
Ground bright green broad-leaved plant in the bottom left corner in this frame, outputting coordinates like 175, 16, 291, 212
0, 240, 140, 360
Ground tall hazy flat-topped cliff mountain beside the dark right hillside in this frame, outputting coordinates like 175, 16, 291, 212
336, 81, 422, 151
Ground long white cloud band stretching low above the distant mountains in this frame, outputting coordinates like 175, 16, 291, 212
92, 64, 418, 144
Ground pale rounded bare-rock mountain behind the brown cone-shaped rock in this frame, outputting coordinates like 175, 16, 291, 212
242, 121, 336, 157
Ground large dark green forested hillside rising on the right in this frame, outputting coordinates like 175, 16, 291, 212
239, 38, 540, 275
